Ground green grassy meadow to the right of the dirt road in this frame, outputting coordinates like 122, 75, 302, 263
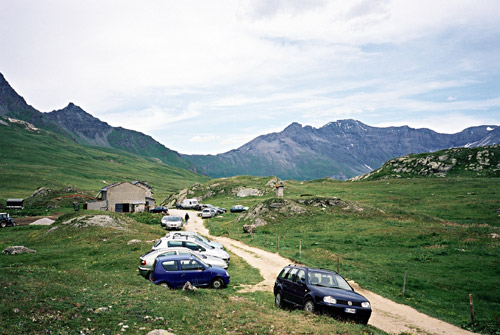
182, 177, 500, 333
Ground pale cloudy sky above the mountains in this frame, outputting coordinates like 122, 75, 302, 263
0, 0, 500, 154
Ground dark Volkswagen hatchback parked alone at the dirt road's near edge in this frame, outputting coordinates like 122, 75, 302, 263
274, 265, 372, 324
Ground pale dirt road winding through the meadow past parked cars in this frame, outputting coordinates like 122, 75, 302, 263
175, 210, 474, 335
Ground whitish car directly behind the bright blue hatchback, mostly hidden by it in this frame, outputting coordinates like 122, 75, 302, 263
139, 248, 228, 278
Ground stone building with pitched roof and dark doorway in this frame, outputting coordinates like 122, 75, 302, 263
85, 181, 155, 213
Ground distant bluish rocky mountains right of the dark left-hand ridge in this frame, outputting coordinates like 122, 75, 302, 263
183, 120, 500, 180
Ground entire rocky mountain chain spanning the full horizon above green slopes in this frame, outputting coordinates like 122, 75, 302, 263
0, 73, 500, 180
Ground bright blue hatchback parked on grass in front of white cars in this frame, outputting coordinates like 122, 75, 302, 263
151, 254, 229, 289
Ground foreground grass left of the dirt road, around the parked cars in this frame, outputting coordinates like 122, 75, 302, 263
0, 212, 384, 335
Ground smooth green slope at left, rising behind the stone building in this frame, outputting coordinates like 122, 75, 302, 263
0, 119, 208, 200
